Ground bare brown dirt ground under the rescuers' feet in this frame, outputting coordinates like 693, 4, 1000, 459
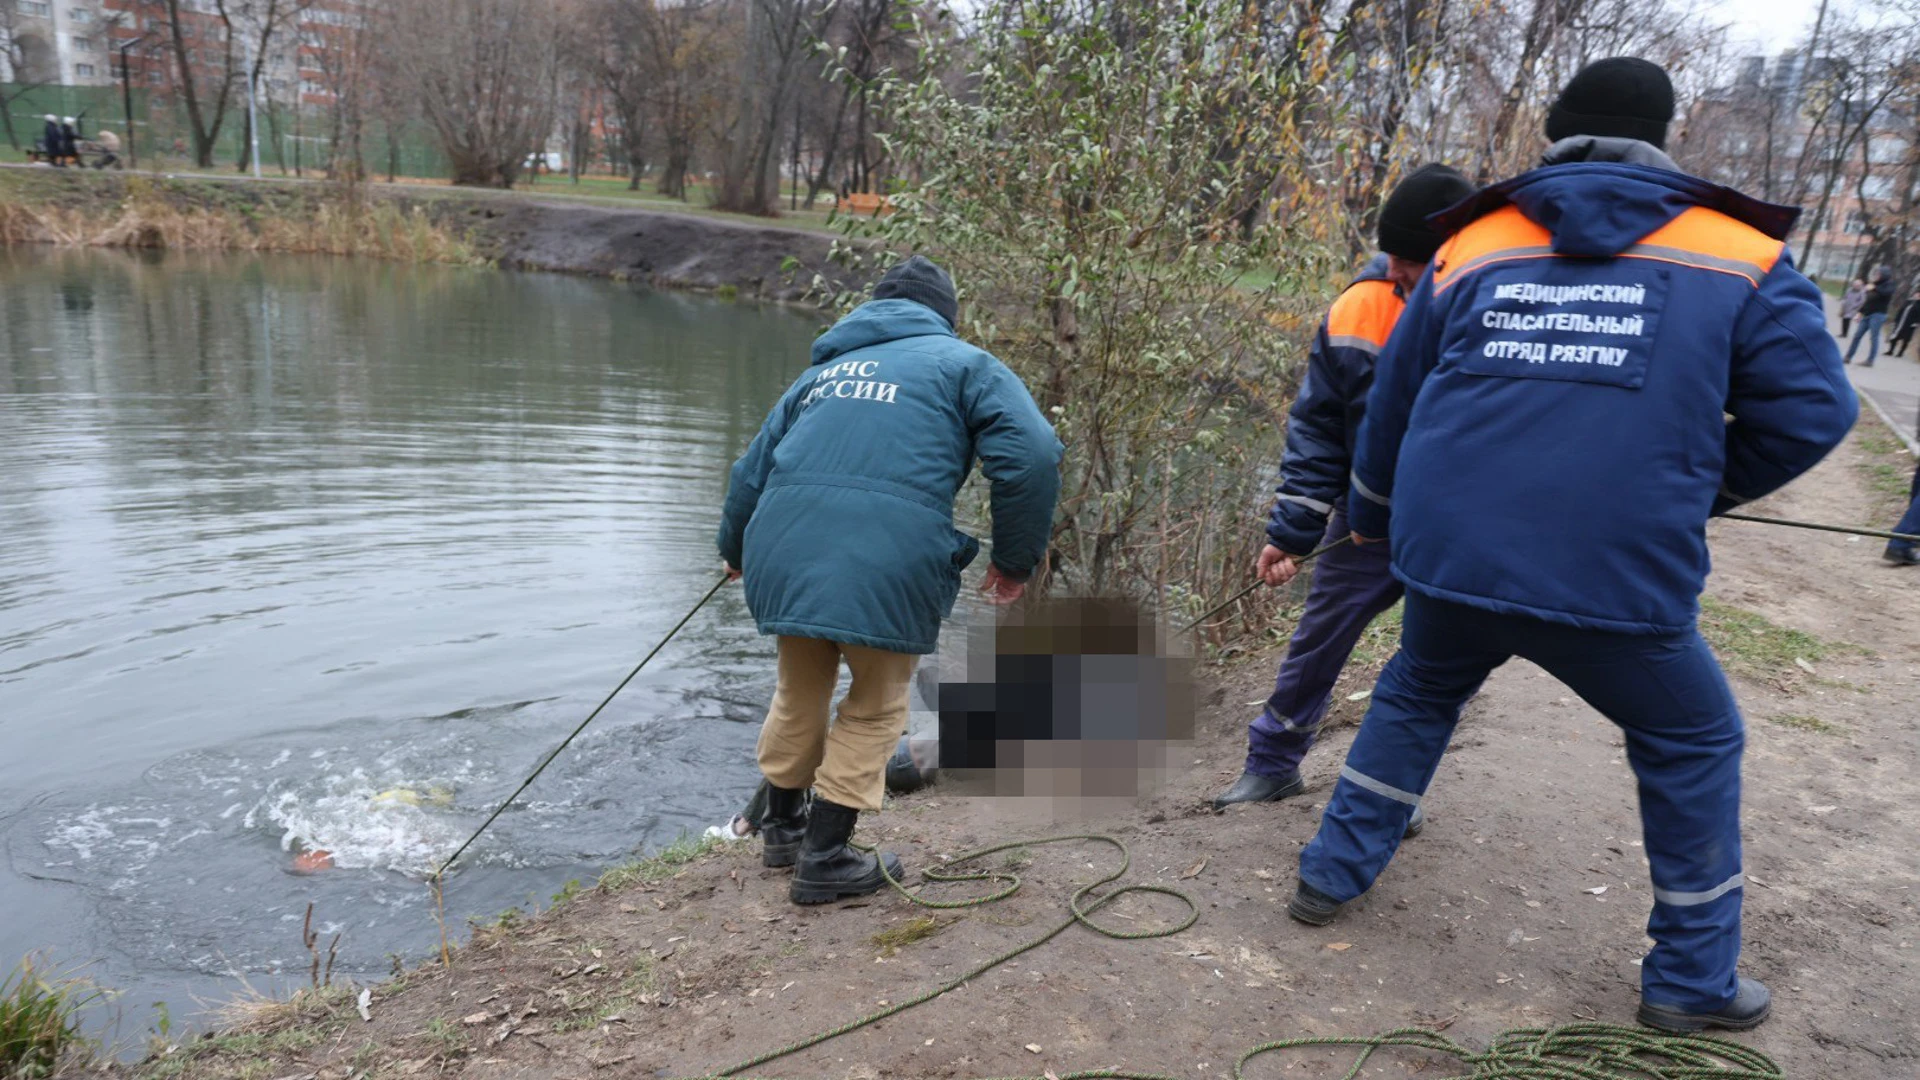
139, 418, 1920, 1080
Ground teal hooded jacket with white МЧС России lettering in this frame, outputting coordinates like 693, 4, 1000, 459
720, 300, 1062, 653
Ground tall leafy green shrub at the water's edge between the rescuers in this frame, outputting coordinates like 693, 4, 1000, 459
821, 0, 1352, 615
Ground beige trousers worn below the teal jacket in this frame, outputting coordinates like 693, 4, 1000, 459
760, 636, 920, 811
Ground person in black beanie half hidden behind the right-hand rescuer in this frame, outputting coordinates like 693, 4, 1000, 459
1213, 165, 1473, 818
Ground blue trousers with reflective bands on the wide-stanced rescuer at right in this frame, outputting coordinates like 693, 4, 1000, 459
1300, 592, 1745, 1011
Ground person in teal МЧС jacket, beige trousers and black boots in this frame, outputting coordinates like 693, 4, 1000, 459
720, 256, 1062, 903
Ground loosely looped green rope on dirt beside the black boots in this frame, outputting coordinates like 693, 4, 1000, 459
712, 832, 1200, 1080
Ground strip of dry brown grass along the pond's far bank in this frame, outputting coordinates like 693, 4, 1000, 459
0, 169, 486, 263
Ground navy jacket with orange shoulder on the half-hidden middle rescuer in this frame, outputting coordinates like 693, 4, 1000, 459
1267, 256, 1405, 555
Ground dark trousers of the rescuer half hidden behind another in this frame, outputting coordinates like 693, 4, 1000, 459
1246, 507, 1404, 780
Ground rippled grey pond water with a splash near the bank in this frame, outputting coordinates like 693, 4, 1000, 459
0, 250, 816, 1036
